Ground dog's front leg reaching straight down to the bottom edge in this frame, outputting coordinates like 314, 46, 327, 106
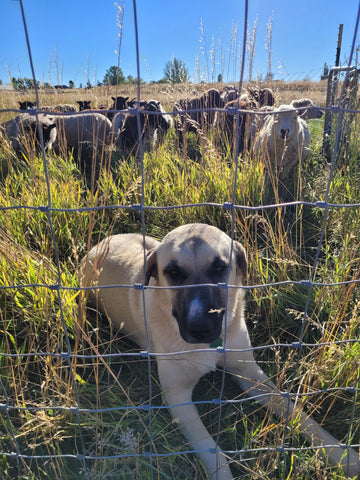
158, 358, 233, 480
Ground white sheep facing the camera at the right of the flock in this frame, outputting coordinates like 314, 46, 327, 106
254, 105, 310, 177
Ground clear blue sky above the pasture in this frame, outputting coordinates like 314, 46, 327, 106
0, 0, 360, 86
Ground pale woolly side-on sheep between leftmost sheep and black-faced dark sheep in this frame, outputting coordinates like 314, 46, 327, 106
54, 112, 112, 150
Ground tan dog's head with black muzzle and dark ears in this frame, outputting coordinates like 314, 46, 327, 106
147, 224, 247, 343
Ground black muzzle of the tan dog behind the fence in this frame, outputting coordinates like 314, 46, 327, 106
172, 287, 225, 343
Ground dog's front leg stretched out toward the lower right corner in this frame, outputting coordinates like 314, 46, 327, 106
225, 352, 360, 477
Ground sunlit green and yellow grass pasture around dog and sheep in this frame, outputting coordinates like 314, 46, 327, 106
0, 81, 360, 480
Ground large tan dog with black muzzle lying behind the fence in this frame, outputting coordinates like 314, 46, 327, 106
79, 223, 360, 480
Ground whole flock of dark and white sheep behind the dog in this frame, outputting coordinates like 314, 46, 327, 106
1, 87, 322, 180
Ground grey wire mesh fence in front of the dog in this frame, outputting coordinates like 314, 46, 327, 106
0, 0, 360, 479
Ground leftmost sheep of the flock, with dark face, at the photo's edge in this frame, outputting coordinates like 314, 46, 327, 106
1, 113, 57, 156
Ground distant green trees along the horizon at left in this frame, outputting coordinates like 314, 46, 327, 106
7, 58, 190, 91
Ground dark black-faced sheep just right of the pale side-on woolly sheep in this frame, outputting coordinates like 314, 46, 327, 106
113, 100, 173, 152
